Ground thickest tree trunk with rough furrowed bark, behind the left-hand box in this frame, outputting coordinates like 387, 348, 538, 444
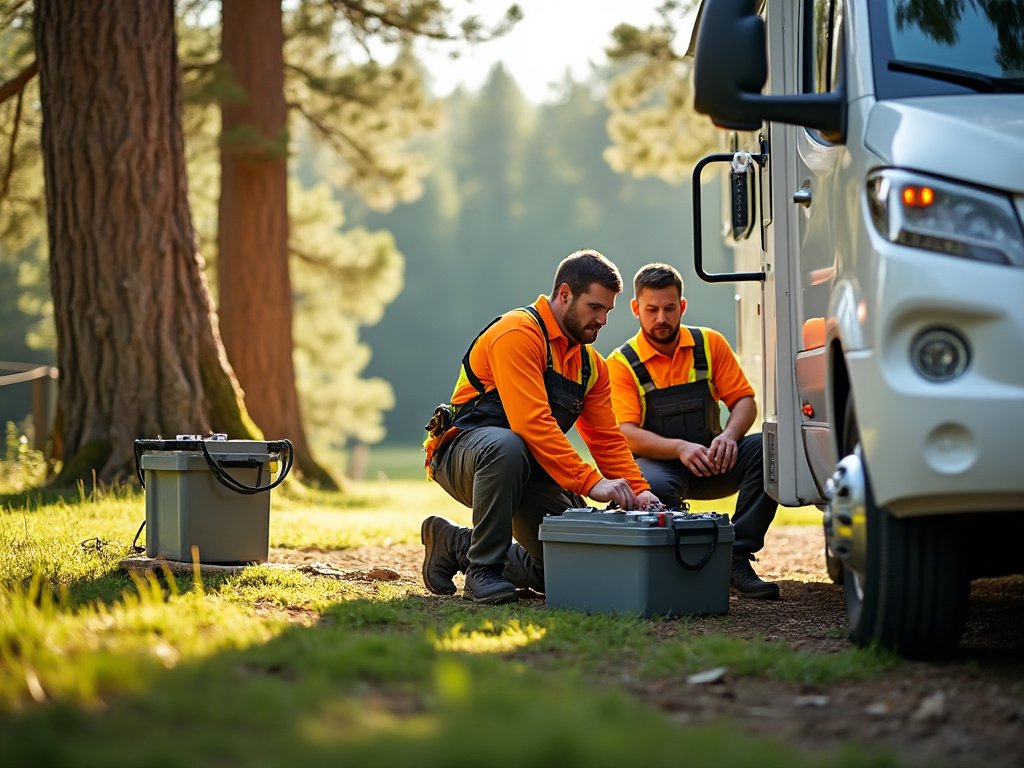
35, 0, 260, 482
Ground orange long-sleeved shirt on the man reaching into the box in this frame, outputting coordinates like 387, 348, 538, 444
452, 295, 650, 496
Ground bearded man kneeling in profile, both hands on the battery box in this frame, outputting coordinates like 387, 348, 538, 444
421, 250, 657, 603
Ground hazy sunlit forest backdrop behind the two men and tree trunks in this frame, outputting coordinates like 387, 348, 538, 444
0, 0, 736, 487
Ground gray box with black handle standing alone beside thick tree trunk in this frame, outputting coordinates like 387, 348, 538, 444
135, 435, 292, 564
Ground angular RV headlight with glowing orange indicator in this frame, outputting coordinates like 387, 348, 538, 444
867, 169, 1024, 266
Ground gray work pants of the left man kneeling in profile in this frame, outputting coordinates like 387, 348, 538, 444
433, 427, 584, 592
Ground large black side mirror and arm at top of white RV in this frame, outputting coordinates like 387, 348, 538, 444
693, 0, 846, 139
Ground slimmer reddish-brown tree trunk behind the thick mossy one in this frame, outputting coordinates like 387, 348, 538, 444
217, 0, 336, 487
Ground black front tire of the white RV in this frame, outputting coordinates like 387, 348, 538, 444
843, 401, 970, 657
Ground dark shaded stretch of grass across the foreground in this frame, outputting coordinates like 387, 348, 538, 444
0, 597, 892, 768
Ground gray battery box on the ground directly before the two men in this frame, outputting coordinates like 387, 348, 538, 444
540, 507, 735, 617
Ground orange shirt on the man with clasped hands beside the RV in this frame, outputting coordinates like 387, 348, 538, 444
607, 326, 754, 425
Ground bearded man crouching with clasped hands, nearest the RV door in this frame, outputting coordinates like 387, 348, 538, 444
608, 264, 778, 600
